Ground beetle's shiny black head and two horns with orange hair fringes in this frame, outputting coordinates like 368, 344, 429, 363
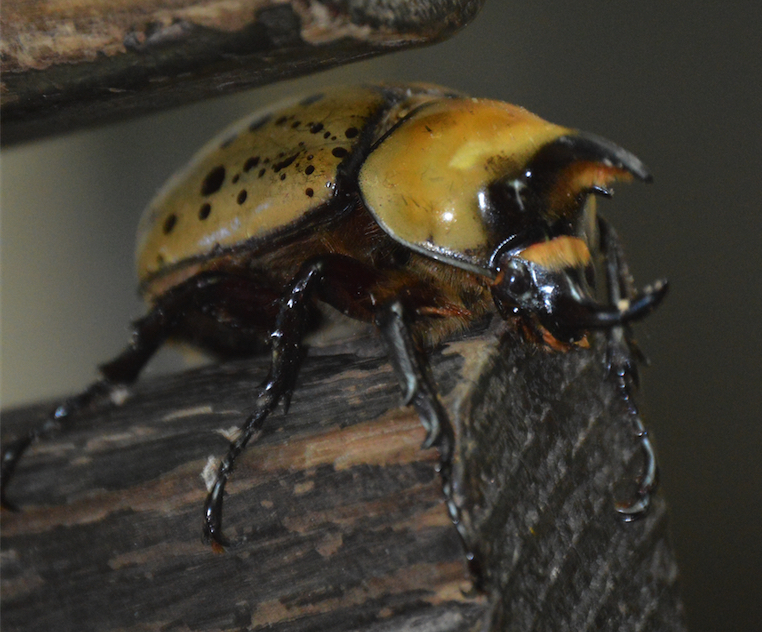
489, 134, 667, 342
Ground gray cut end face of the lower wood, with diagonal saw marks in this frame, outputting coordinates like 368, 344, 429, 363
454, 332, 685, 632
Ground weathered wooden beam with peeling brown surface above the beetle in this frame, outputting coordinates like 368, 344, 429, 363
0, 0, 484, 143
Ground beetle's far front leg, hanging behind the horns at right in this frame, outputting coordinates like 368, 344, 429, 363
598, 217, 658, 522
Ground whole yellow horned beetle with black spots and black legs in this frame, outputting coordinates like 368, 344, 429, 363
2, 84, 667, 549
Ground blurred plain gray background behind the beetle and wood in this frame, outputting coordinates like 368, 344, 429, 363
1, 0, 762, 631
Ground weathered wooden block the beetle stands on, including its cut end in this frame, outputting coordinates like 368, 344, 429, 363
1, 324, 684, 632
